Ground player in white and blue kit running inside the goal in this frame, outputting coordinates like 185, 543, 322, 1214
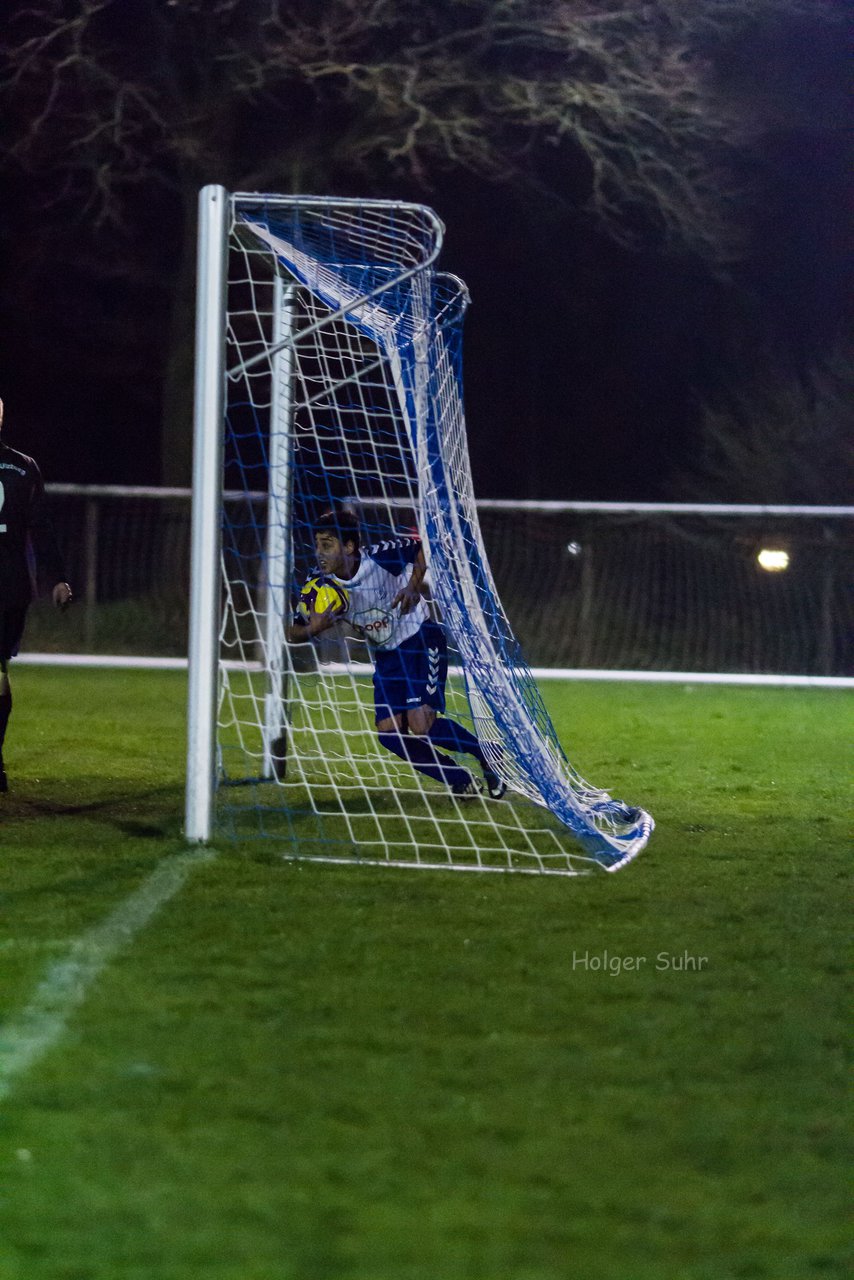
288, 512, 507, 800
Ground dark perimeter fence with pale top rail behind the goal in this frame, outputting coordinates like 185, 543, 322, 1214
20, 484, 854, 685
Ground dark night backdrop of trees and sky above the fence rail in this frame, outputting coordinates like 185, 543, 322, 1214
0, 0, 854, 500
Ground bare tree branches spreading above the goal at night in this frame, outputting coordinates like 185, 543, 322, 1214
0, 0, 832, 479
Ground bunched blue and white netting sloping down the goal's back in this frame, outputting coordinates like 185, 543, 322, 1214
230, 198, 653, 870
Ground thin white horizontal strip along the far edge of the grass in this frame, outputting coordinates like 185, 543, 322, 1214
15, 653, 854, 689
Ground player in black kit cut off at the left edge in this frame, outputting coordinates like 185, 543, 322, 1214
0, 401, 72, 791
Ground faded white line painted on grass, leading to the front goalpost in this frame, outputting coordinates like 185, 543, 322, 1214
0, 849, 216, 1102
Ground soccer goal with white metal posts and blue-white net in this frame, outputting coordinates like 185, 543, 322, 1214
186, 187, 653, 876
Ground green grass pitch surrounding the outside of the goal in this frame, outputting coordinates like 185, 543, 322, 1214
0, 667, 851, 1280
